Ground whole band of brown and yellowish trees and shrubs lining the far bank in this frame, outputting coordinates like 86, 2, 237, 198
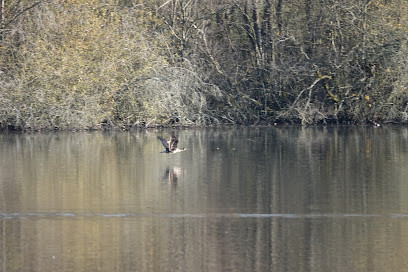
0, 0, 408, 130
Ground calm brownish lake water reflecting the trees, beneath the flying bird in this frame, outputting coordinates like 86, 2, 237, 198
0, 127, 408, 272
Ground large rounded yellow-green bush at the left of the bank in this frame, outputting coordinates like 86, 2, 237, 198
0, 0, 166, 129
